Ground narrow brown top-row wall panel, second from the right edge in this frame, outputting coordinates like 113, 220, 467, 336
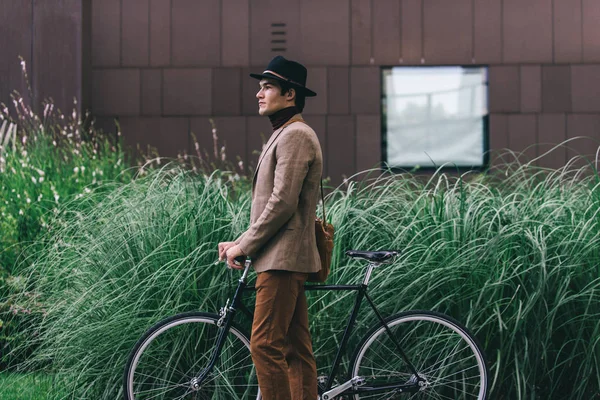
553, 0, 582, 63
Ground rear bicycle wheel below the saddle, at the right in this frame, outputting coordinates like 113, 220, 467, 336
352, 311, 488, 400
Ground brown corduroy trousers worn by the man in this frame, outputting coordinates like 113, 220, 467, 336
250, 270, 317, 400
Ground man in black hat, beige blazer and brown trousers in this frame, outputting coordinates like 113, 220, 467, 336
219, 56, 323, 400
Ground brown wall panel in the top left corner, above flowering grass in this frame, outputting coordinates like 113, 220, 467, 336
0, 1, 33, 110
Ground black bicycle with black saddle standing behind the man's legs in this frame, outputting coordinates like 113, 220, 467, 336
123, 250, 488, 400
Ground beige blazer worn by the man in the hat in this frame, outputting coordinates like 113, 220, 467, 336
235, 114, 323, 272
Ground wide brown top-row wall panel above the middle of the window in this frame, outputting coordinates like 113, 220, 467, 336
423, 0, 473, 64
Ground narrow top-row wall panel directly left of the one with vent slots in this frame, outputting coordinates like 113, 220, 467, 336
221, 0, 250, 67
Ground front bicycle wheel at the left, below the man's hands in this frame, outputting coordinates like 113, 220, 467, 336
124, 312, 260, 400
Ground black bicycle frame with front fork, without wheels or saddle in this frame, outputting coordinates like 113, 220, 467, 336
197, 269, 424, 394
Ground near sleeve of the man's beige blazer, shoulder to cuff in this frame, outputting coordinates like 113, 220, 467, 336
238, 130, 316, 256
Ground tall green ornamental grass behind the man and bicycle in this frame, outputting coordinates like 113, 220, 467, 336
11, 157, 600, 400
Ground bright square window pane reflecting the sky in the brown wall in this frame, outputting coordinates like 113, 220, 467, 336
383, 67, 488, 167
